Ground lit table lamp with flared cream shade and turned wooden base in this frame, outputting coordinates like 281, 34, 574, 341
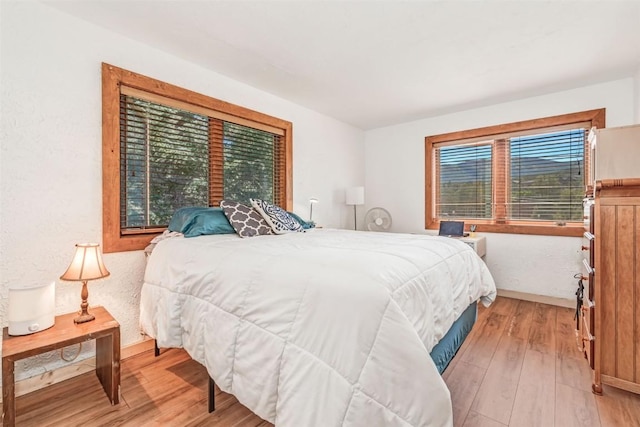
60, 243, 110, 323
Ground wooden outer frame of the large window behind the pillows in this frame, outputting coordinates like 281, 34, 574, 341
102, 63, 293, 253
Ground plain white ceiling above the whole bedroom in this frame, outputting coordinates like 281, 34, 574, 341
45, 0, 640, 130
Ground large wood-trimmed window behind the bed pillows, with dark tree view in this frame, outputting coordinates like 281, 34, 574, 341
102, 64, 292, 252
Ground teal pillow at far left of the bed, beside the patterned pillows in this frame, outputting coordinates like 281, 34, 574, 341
169, 206, 235, 237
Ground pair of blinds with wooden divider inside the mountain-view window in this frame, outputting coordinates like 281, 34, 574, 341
434, 128, 588, 223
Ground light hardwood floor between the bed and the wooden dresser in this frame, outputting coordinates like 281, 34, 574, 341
443, 298, 640, 427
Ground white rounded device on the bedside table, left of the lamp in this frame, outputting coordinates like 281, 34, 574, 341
7, 282, 56, 335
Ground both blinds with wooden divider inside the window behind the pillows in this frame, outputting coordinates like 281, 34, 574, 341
120, 95, 285, 230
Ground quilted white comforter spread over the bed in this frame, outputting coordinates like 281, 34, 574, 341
140, 230, 495, 427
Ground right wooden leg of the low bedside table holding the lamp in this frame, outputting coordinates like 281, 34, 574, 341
96, 330, 120, 405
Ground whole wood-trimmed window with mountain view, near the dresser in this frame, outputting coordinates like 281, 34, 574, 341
425, 109, 605, 236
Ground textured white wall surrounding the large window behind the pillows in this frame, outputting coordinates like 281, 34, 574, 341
0, 1, 364, 378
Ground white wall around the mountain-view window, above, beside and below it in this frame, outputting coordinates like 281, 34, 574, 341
365, 78, 634, 298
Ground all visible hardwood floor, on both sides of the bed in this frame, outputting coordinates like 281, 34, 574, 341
16, 298, 640, 427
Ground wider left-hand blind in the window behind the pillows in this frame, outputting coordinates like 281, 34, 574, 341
120, 95, 209, 229
